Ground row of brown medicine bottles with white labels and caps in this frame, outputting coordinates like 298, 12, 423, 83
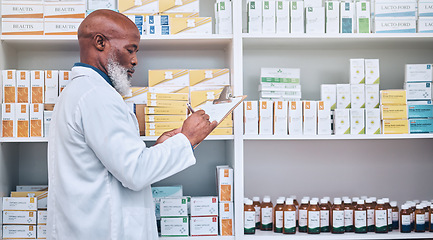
244, 196, 433, 234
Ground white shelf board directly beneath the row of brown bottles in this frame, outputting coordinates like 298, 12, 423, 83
248, 230, 433, 240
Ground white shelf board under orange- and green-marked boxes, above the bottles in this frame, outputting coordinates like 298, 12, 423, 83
244, 134, 433, 140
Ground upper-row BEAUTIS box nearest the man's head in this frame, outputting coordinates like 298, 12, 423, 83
44, 2, 86, 19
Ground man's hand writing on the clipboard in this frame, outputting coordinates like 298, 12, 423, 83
181, 110, 218, 146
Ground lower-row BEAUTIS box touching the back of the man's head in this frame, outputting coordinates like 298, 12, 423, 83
44, 18, 84, 35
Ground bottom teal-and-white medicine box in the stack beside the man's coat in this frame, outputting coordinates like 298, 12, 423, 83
161, 217, 189, 237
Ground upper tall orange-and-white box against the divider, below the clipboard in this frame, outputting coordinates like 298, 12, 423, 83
216, 166, 233, 202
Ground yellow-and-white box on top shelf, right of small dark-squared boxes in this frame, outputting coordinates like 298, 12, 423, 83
170, 17, 212, 35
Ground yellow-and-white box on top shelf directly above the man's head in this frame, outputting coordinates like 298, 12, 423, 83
117, 0, 159, 14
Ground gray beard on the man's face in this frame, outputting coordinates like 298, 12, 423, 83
107, 56, 132, 96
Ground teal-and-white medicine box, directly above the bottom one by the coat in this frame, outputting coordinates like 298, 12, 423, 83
160, 197, 190, 217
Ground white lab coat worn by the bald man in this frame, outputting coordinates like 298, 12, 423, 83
48, 67, 195, 240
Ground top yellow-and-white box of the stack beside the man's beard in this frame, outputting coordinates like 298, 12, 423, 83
149, 69, 189, 87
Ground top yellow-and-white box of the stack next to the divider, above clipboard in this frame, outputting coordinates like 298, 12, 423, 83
189, 68, 230, 86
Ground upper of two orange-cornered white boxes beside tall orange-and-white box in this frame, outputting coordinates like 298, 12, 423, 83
191, 197, 218, 218
